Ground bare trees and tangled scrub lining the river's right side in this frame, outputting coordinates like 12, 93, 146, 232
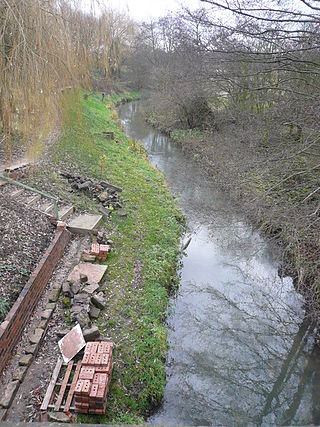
127, 0, 320, 320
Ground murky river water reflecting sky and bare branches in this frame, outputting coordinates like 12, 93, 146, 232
120, 102, 320, 426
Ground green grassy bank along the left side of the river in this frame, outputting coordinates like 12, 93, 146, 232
25, 94, 183, 423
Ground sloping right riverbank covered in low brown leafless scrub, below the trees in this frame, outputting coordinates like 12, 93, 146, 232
146, 104, 320, 319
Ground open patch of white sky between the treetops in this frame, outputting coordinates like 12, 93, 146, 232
88, 0, 203, 21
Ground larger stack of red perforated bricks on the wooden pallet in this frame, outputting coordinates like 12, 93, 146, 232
75, 341, 113, 415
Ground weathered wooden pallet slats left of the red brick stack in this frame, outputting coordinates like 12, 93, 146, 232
40, 359, 81, 414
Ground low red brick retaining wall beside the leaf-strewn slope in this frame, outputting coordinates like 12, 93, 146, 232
0, 230, 71, 373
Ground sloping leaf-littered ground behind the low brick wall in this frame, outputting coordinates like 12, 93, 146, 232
0, 194, 54, 322
